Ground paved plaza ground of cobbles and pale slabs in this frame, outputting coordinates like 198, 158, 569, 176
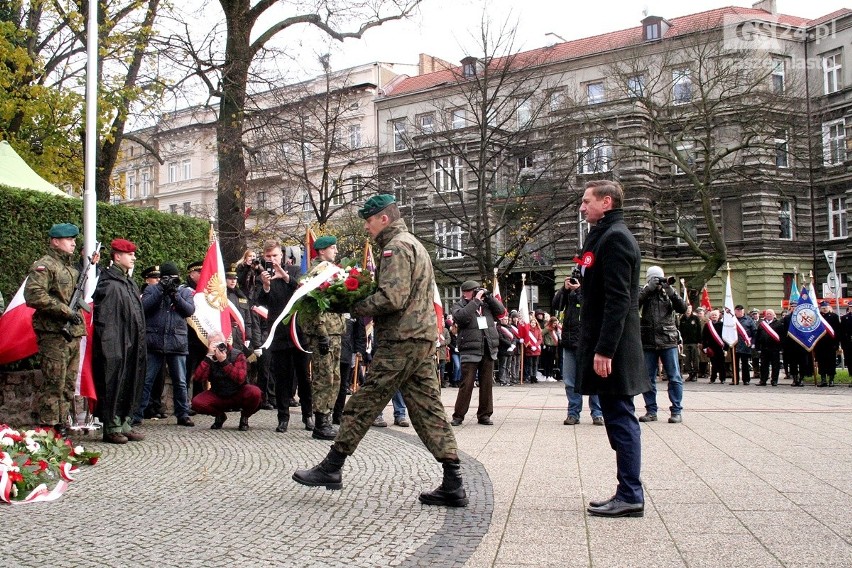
0, 374, 852, 568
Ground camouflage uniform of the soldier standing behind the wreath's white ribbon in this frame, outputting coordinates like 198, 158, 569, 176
299, 258, 346, 414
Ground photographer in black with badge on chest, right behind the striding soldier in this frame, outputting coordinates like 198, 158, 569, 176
451, 280, 506, 426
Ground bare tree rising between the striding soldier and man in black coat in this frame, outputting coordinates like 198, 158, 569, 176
390, 18, 579, 281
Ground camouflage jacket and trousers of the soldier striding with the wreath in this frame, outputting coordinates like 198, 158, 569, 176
340, 219, 458, 462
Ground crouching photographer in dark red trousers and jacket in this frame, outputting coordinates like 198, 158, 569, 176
192, 332, 261, 432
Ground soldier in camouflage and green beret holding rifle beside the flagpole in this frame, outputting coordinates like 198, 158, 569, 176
24, 223, 86, 434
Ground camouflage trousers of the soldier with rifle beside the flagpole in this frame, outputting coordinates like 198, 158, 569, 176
33, 331, 80, 425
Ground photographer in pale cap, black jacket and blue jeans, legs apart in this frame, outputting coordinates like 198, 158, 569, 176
639, 266, 686, 424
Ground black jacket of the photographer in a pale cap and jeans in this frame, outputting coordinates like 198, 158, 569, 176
639, 284, 686, 351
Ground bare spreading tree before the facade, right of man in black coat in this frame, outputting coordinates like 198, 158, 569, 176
574, 29, 807, 295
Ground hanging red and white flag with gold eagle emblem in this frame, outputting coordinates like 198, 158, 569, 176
187, 233, 245, 341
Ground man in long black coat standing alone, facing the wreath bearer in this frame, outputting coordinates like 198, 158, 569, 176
576, 180, 651, 517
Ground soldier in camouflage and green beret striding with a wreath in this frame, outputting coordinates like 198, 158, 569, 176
293, 195, 468, 507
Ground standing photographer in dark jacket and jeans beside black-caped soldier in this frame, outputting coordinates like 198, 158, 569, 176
133, 262, 195, 426
